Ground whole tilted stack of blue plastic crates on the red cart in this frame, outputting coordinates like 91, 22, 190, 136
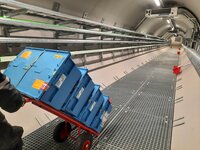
4, 48, 112, 132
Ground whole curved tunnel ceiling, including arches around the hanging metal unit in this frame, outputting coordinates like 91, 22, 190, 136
19, 0, 200, 39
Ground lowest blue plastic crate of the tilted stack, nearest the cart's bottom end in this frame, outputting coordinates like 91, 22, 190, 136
91, 96, 112, 132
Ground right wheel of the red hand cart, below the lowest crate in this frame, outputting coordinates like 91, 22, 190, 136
77, 132, 93, 150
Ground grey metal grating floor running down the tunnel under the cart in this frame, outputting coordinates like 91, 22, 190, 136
24, 50, 178, 150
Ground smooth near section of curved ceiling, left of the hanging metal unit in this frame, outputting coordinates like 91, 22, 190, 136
19, 0, 159, 28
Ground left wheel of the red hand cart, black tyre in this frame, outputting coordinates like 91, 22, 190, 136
53, 122, 72, 143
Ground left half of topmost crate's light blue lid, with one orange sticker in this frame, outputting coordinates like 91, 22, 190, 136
4, 48, 44, 86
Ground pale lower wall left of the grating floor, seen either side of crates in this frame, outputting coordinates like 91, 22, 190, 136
0, 48, 167, 136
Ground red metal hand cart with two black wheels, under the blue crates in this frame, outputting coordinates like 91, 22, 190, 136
24, 96, 99, 150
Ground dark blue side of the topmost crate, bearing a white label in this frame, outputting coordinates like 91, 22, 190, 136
41, 59, 81, 110
